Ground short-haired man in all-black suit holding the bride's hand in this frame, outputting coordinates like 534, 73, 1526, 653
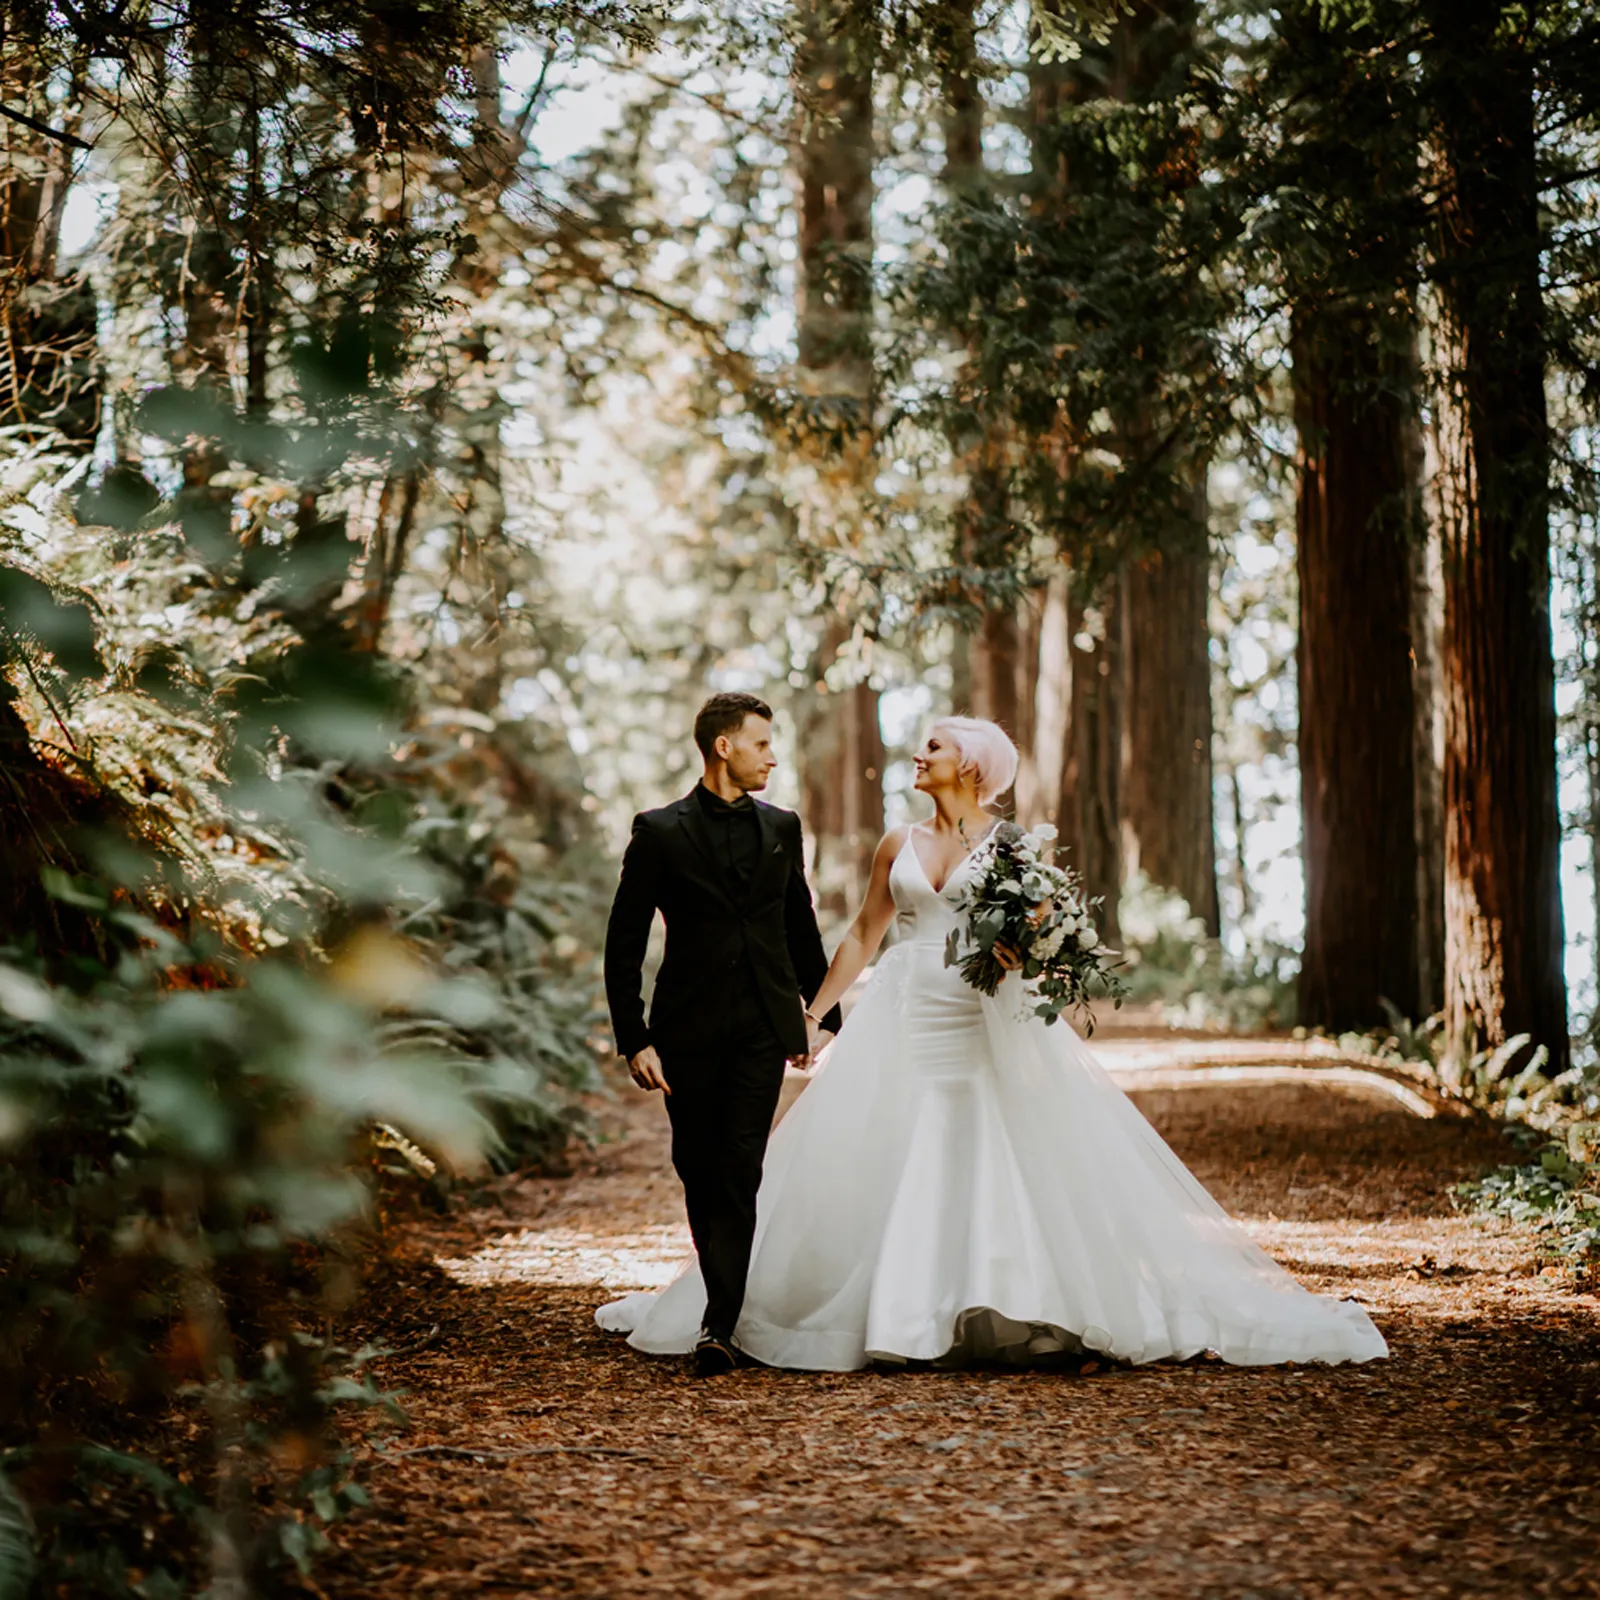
605, 694, 838, 1376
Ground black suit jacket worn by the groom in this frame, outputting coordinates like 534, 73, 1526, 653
605, 792, 838, 1062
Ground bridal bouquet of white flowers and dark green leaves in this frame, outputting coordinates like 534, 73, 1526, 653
944, 822, 1126, 1032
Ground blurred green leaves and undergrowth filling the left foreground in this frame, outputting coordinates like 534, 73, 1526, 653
0, 339, 594, 1597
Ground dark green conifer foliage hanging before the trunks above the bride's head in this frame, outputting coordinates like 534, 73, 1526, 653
880, 32, 1228, 605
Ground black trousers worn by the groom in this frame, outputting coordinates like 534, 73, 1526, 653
661, 986, 786, 1339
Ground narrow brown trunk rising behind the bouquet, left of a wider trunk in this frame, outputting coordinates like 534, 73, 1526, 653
1056, 574, 1125, 944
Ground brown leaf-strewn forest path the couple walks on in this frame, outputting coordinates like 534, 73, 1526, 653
317, 1037, 1600, 1600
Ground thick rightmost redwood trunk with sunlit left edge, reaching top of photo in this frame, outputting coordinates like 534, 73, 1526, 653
1424, 0, 1568, 1070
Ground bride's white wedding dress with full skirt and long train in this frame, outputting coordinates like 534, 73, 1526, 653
595, 835, 1387, 1371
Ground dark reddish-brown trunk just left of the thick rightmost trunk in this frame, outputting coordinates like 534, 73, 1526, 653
1293, 306, 1419, 1029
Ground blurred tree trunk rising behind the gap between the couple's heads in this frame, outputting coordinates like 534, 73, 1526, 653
795, 0, 883, 909
